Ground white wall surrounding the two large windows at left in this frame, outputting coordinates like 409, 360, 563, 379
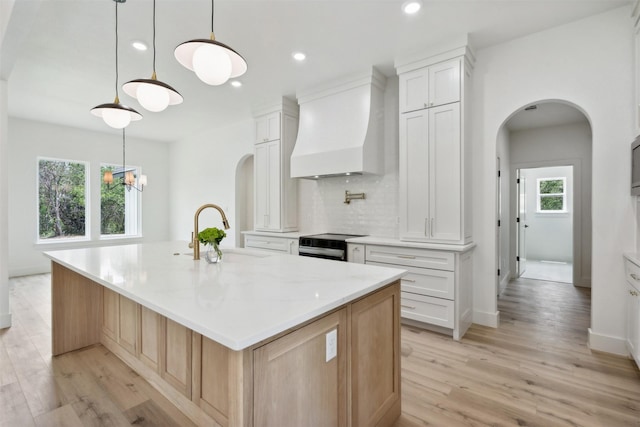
8, 118, 170, 276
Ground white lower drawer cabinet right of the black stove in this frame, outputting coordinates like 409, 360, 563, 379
365, 245, 473, 340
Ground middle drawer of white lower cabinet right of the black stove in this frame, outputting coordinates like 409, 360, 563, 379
367, 262, 455, 300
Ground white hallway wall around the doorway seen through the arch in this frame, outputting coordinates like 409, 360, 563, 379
510, 122, 593, 287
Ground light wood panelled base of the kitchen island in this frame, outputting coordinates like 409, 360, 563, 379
51, 262, 401, 426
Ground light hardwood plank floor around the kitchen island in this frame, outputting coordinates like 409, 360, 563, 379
0, 275, 640, 427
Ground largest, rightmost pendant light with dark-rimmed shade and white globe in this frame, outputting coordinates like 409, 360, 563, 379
173, 0, 247, 86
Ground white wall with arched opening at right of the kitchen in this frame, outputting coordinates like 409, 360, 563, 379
472, 6, 635, 354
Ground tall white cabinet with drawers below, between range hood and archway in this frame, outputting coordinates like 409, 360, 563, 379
392, 43, 474, 340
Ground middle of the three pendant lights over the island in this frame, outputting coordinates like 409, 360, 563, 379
122, 0, 183, 113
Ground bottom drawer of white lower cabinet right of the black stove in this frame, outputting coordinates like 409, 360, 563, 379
400, 292, 455, 329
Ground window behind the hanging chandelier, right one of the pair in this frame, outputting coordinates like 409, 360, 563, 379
100, 165, 140, 237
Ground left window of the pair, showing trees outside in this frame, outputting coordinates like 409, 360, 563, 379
38, 158, 88, 241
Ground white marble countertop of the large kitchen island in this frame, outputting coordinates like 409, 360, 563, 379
45, 242, 405, 350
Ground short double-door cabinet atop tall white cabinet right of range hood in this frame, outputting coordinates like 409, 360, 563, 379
400, 59, 461, 113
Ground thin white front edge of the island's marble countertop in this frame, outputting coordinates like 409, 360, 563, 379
44, 252, 407, 351
